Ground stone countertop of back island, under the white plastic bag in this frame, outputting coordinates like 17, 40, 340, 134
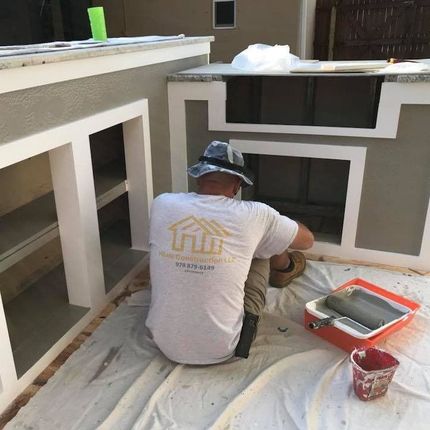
168, 60, 430, 83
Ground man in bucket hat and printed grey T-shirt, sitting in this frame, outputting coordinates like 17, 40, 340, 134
146, 141, 314, 364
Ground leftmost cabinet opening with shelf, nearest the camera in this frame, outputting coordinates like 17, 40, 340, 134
0, 154, 88, 377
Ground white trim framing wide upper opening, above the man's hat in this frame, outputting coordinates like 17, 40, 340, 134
168, 81, 430, 186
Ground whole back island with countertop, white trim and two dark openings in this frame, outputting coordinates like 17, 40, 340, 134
169, 62, 430, 270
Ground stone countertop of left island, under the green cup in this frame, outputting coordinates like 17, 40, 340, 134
0, 35, 214, 70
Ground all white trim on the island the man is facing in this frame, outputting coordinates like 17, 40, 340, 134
168, 81, 430, 270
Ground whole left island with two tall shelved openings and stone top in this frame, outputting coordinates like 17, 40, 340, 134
0, 35, 213, 412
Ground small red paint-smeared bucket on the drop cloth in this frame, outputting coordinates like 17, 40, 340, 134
351, 348, 399, 400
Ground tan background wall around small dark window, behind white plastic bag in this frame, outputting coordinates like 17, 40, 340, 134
118, 0, 300, 62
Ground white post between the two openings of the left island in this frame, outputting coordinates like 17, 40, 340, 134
49, 136, 105, 307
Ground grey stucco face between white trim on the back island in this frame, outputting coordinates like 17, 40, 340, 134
186, 101, 430, 255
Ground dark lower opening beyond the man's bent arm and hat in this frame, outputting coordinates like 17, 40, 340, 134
242, 154, 350, 244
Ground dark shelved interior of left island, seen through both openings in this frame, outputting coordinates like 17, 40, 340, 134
0, 124, 146, 377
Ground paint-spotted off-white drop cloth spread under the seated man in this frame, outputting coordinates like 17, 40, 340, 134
6, 262, 430, 430
